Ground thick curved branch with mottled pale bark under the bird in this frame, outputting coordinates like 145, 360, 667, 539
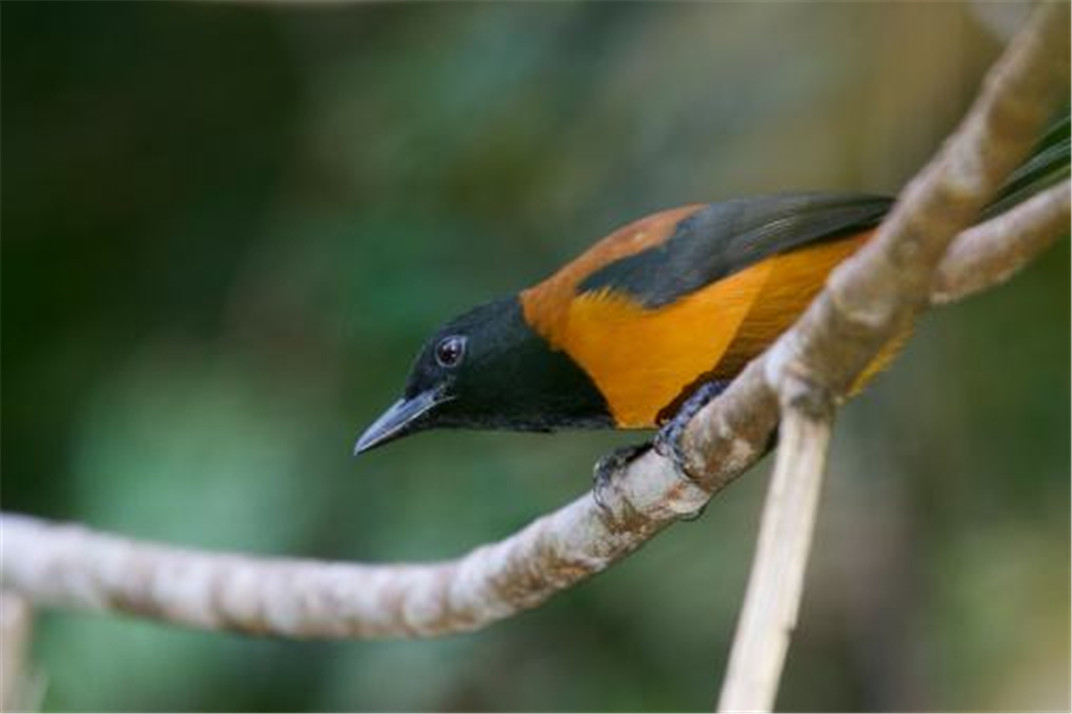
0, 3, 1069, 638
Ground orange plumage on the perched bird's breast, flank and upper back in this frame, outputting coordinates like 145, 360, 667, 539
521, 216, 873, 429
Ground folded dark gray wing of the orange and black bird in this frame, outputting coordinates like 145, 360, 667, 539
578, 193, 893, 308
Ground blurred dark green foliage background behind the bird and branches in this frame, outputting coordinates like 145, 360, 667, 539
2, 2, 1070, 711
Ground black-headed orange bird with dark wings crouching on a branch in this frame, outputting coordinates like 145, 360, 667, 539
354, 114, 1069, 486
